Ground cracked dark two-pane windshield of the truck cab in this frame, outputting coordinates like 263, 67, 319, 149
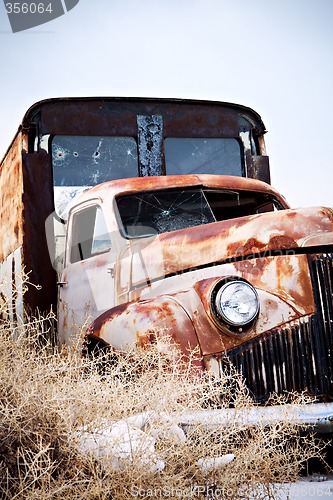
116, 188, 283, 238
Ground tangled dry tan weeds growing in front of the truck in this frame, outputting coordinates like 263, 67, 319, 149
0, 310, 328, 500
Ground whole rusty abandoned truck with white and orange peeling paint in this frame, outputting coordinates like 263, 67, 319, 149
0, 98, 333, 430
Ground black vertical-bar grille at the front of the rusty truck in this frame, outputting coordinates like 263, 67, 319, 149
222, 254, 333, 402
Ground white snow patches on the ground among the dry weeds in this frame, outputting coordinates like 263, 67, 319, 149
71, 412, 333, 500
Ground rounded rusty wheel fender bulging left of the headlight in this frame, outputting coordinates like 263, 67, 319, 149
87, 295, 203, 371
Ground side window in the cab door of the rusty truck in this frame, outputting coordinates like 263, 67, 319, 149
70, 206, 111, 263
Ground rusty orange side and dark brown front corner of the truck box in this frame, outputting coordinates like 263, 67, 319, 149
0, 138, 56, 312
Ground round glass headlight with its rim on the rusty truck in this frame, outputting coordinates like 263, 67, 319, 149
212, 277, 259, 332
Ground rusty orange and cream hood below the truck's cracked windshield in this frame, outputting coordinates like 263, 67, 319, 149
131, 207, 333, 285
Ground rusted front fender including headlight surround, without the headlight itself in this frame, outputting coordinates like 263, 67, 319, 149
87, 270, 308, 360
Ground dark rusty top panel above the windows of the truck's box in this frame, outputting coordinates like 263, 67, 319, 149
22, 97, 266, 143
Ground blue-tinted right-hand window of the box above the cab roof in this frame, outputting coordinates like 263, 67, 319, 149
164, 137, 244, 176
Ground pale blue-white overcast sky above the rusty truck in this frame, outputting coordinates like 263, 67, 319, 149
0, 0, 333, 206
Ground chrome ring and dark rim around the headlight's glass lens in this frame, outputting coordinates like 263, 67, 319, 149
210, 276, 260, 334
